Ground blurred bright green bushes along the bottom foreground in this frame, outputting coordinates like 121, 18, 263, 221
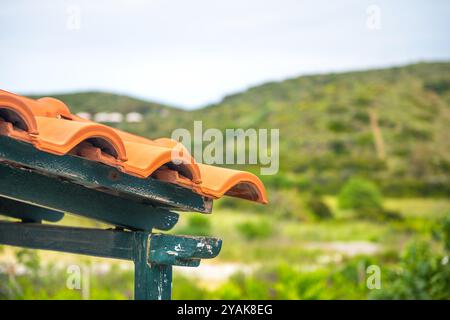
0, 212, 450, 299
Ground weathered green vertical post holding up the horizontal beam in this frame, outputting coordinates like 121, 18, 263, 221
133, 232, 172, 300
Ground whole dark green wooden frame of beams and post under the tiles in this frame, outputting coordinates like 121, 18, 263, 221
0, 136, 222, 299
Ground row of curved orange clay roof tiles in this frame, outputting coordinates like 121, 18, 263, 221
0, 90, 268, 203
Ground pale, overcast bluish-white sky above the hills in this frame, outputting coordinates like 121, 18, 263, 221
0, 0, 450, 108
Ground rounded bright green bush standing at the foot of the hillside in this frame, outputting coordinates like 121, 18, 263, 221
338, 178, 383, 211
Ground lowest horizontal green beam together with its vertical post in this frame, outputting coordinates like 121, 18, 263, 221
0, 222, 222, 300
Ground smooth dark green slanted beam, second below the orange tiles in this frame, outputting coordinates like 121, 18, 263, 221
0, 164, 178, 231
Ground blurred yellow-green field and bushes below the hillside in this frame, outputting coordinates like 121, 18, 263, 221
0, 198, 450, 299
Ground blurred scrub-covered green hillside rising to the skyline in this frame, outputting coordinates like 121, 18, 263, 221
29, 63, 450, 195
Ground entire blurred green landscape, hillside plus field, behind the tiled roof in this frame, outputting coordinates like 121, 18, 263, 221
0, 63, 450, 299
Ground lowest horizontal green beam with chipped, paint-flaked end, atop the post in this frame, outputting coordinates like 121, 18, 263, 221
0, 221, 222, 266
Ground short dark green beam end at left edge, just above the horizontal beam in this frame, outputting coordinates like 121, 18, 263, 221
0, 197, 64, 222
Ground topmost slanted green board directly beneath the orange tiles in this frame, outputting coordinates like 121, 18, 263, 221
0, 136, 212, 213
